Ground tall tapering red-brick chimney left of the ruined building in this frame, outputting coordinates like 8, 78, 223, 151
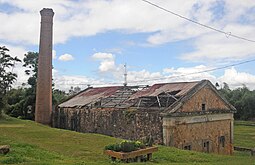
35, 8, 54, 125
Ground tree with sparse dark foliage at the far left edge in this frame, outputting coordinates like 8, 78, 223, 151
0, 46, 21, 114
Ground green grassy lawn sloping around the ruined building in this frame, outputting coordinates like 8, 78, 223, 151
0, 118, 255, 165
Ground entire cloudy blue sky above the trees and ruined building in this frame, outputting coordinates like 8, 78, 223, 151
0, 0, 255, 91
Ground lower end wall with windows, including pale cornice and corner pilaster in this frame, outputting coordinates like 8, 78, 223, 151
163, 114, 233, 154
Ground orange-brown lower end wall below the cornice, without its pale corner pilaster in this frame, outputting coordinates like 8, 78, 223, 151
174, 120, 233, 154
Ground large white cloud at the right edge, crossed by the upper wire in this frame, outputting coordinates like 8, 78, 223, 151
181, 25, 255, 62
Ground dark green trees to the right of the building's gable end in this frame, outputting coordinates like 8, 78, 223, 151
219, 83, 255, 120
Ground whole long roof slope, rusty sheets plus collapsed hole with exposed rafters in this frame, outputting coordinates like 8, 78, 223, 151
59, 81, 200, 108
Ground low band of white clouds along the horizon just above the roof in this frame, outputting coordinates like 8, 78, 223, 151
45, 65, 255, 91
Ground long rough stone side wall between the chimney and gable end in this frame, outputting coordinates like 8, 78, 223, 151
53, 108, 163, 144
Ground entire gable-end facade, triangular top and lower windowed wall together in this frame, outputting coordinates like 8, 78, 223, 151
163, 86, 233, 154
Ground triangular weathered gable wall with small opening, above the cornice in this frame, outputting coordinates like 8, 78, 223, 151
178, 87, 229, 112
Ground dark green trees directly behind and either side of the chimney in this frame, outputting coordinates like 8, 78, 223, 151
4, 52, 67, 120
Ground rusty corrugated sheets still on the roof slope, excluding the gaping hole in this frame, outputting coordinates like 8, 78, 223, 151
59, 81, 200, 107
